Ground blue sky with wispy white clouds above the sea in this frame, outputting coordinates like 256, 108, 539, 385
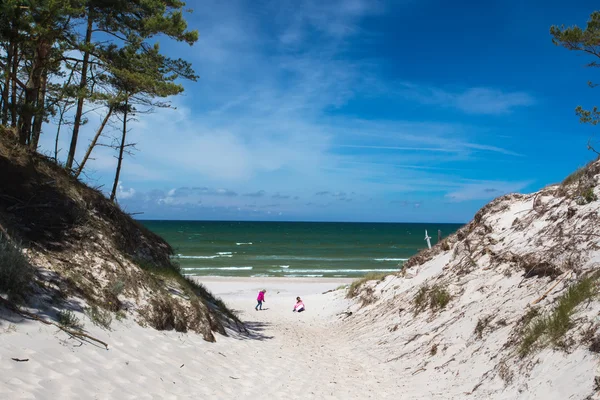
42, 0, 600, 222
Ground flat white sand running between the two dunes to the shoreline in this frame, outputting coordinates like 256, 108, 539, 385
0, 278, 392, 399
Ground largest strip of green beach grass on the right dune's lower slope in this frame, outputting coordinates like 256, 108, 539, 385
519, 275, 598, 357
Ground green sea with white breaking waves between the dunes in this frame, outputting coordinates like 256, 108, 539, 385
140, 220, 461, 278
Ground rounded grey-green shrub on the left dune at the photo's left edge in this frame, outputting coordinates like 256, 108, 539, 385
0, 233, 34, 301
